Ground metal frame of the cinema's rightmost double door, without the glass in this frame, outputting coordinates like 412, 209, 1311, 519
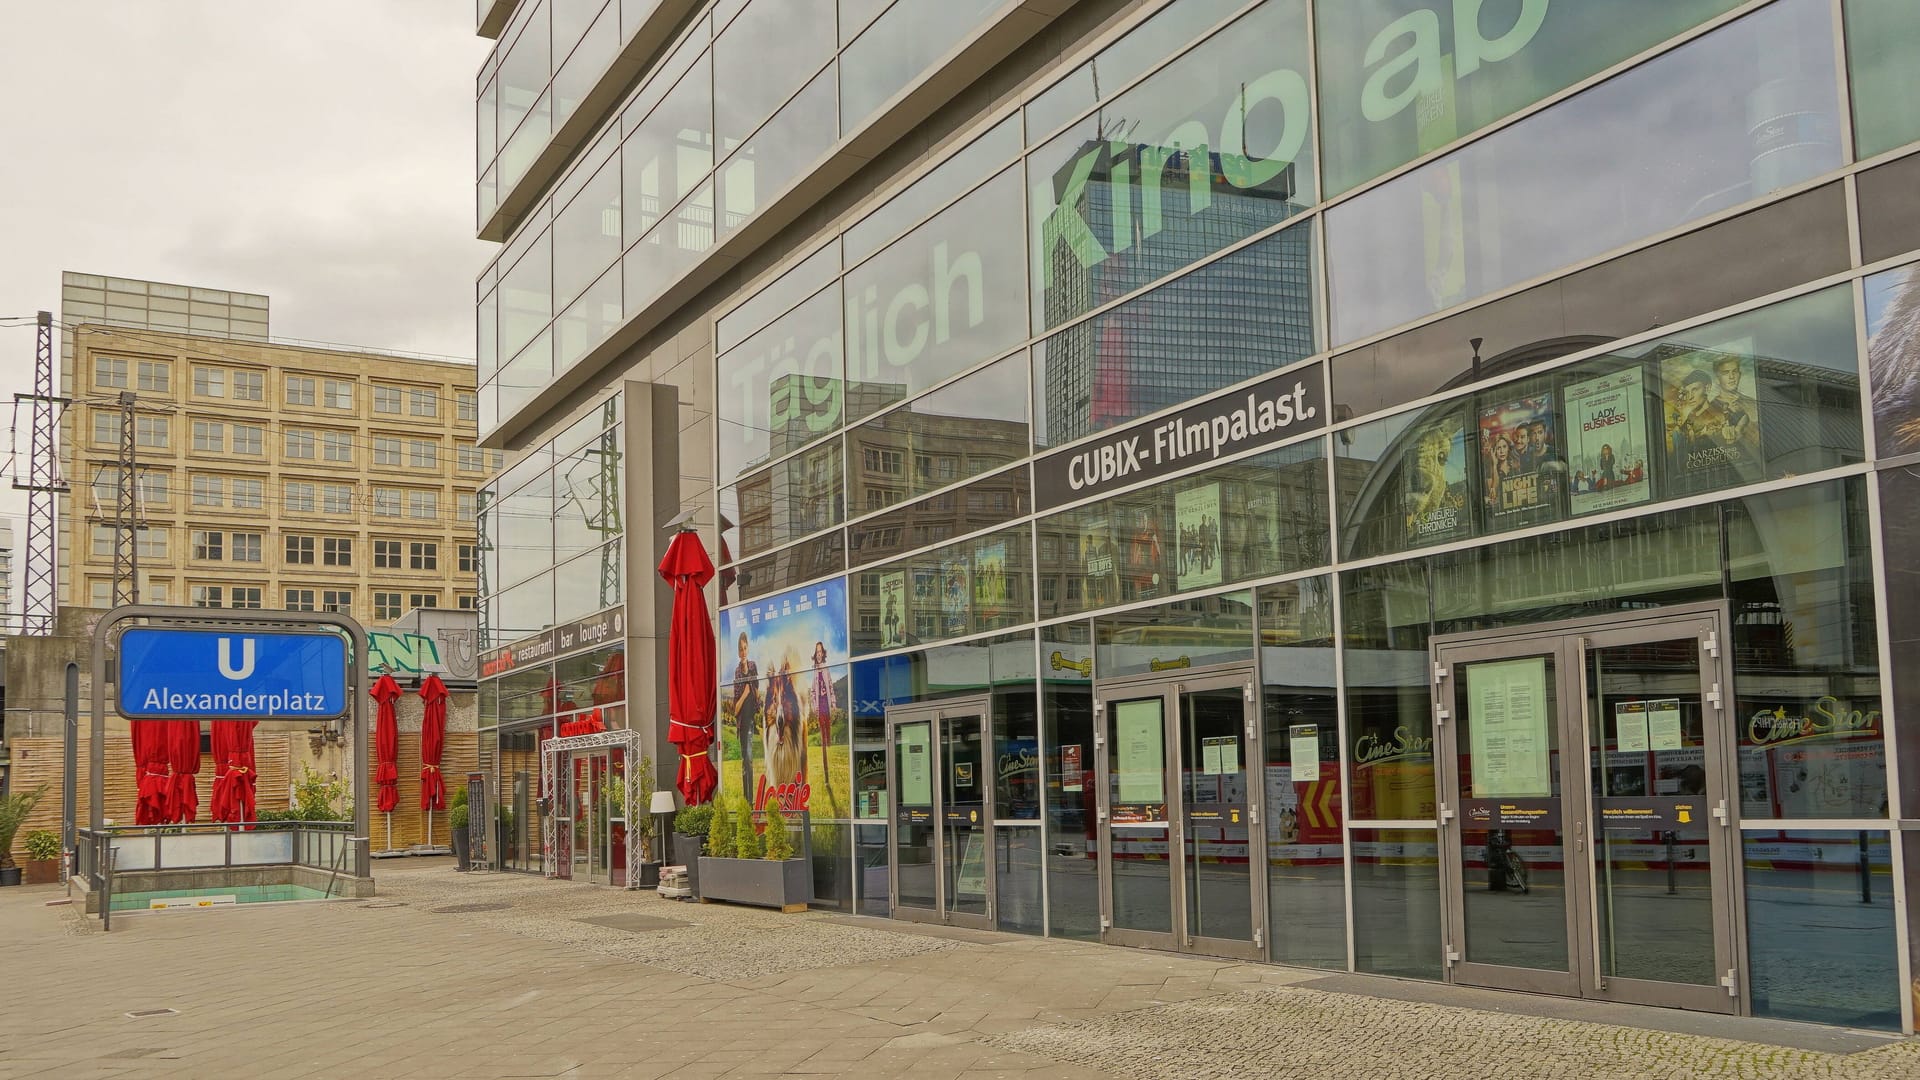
1428, 601, 1751, 1015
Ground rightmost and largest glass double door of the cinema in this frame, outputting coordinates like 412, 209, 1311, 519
1434, 611, 1740, 1011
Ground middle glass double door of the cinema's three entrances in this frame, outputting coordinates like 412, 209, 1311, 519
1094, 671, 1265, 959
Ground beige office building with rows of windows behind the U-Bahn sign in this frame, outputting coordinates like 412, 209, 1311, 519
60, 322, 497, 626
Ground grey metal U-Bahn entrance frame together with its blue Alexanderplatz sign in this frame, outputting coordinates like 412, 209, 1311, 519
86, 605, 371, 878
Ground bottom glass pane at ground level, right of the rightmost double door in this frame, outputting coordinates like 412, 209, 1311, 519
1741, 830, 1901, 1030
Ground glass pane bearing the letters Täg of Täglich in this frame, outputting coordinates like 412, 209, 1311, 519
720, 284, 845, 484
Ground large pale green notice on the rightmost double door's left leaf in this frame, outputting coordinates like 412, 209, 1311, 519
1467, 657, 1553, 799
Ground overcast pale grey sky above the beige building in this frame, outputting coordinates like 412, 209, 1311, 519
0, 0, 493, 530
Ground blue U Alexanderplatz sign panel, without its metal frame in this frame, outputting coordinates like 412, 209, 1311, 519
117, 626, 349, 721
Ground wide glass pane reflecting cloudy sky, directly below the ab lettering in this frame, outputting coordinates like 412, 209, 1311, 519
1327, 0, 1841, 342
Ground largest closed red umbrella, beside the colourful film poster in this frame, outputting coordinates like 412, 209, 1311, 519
660, 532, 720, 807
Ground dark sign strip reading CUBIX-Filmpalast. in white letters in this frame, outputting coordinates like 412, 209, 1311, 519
1033, 363, 1327, 511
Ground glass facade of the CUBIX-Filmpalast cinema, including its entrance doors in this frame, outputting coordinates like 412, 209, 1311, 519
478, 0, 1920, 1028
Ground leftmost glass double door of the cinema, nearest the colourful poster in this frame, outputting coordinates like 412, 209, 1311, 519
887, 700, 995, 930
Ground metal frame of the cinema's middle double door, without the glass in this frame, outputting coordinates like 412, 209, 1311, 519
1092, 663, 1267, 961
